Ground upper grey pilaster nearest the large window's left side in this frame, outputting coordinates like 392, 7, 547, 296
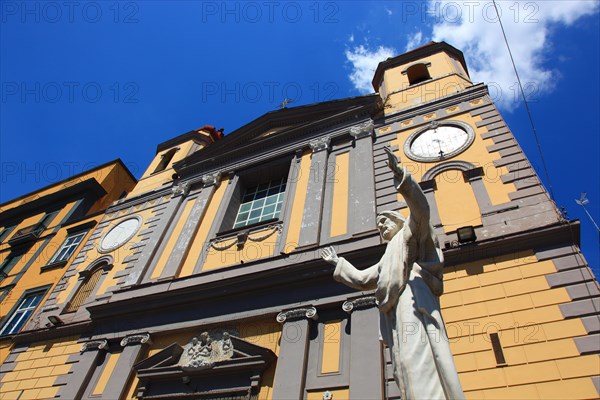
160, 175, 220, 279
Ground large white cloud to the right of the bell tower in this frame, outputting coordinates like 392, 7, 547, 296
428, 0, 600, 110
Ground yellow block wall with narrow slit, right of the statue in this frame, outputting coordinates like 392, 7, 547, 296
441, 252, 600, 399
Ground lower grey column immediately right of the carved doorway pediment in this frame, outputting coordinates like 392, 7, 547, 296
273, 306, 317, 400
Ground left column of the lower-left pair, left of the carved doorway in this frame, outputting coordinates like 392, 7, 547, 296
59, 339, 108, 399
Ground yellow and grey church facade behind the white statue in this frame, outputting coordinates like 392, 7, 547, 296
0, 42, 600, 400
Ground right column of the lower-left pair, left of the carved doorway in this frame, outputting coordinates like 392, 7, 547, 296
102, 333, 150, 399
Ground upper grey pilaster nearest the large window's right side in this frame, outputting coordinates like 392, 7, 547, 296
298, 137, 329, 246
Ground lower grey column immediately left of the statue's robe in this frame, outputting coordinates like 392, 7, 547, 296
342, 296, 383, 400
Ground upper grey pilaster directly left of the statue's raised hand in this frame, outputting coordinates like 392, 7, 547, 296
348, 120, 375, 234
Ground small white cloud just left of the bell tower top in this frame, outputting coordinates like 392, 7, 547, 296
346, 45, 397, 94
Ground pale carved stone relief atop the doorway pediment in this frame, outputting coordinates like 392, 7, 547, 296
179, 332, 233, 368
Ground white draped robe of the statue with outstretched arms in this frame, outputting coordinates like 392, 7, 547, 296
334, 170, 464, 399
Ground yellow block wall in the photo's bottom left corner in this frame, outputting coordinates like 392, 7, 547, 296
0, 337, 81, 400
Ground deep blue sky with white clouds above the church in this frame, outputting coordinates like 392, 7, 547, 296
0, 1, 600, 275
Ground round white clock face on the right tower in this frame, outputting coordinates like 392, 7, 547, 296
404, 123, 474, 162
